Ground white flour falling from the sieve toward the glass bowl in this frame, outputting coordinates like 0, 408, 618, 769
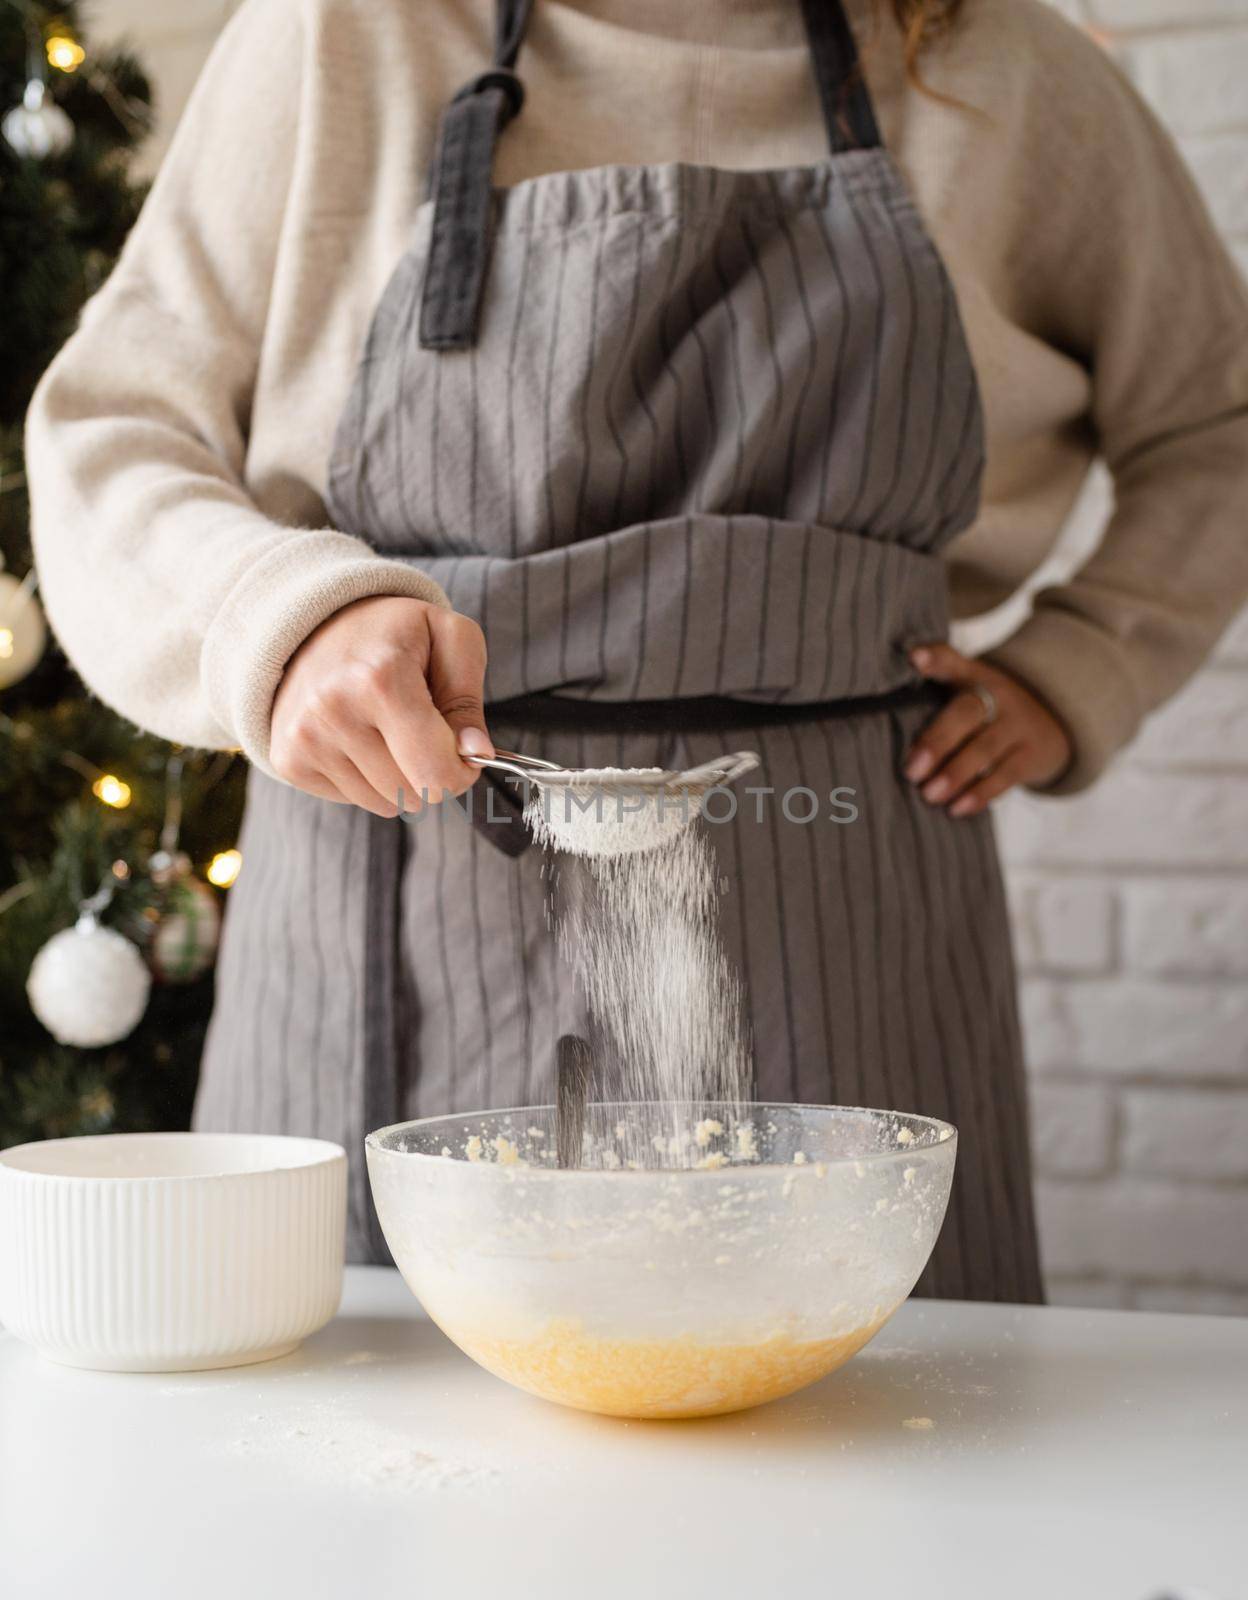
526, 768, 752, 1166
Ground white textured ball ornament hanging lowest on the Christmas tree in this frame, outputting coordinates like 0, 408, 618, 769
26, 917, 152, 1050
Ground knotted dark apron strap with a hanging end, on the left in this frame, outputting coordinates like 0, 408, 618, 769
421, 0, 533, 350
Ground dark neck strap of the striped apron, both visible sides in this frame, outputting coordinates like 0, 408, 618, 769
419, 0, 880, 350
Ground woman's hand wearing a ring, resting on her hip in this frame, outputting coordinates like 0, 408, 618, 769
902, 645, 1072, 816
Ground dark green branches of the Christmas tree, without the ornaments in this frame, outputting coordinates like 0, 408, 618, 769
0, 0, 243, 1146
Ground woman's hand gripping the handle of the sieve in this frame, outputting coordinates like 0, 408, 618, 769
269, 595, 494, 816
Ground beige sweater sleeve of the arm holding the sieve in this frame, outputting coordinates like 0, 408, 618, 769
26, 0, 446, 770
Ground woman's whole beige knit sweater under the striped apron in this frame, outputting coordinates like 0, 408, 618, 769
17, 0, 1248, 790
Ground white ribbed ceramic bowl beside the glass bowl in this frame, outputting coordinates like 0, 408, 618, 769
0, 1133, 347, 1373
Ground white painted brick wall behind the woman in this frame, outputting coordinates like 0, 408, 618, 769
93, 0, 1248, 1314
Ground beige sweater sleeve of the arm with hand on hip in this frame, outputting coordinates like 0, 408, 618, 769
990, 6, 1248, 794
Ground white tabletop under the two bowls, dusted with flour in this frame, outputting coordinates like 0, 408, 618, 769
0, 1267, 1248, 1600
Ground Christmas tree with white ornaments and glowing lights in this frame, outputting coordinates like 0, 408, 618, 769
0, 0, 243, 1146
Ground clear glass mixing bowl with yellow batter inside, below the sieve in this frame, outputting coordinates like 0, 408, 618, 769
366, 1102, 957, 1418
